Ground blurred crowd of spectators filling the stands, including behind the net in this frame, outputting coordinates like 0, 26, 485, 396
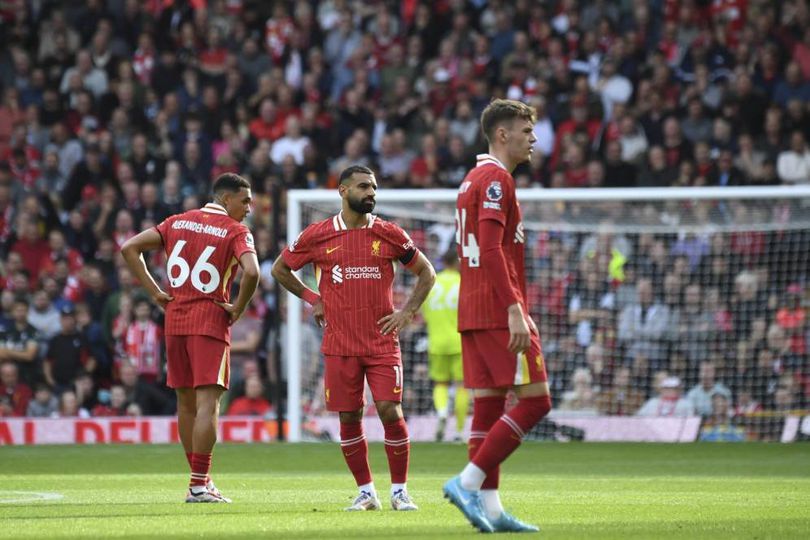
0, 0, 810, 438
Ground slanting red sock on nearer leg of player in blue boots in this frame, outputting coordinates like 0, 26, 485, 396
471, 396, 551, 474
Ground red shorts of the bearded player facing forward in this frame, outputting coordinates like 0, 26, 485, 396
324, 353, 402, 412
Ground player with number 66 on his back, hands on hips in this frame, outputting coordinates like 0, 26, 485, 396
121, 173, 259, 502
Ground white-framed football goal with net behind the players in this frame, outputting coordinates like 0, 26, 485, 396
283, 187, 810, 441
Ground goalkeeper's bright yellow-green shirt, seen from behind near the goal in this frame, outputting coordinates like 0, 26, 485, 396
422, 269, 461, 355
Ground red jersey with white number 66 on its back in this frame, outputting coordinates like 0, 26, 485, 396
155, 203, 256, 343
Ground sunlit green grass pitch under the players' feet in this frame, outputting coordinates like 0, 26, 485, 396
0, 443, 810, 540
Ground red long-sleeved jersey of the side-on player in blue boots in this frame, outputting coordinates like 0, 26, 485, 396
456, 154, 529, 331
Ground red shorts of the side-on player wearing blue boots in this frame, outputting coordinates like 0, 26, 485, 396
461, 328, 548, 388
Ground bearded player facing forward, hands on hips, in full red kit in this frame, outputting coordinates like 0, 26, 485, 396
273, 166, 436, 510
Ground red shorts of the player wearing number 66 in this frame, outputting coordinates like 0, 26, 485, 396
166, 336, 231, 389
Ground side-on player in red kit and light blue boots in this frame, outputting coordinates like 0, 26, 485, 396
444, 99, 551, 532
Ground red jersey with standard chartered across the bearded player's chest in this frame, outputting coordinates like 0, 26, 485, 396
281, 214, 418, 356
